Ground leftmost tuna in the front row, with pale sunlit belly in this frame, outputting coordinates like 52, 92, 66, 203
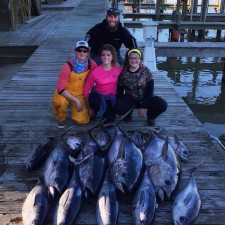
22, 180, 48, 225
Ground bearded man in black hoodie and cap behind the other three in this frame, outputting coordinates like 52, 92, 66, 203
85, 8, 137, 65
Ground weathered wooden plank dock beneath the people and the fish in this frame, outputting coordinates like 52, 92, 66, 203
0, 0, 225, 225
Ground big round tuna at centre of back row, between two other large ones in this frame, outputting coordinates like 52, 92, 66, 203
109, 124, 144, 192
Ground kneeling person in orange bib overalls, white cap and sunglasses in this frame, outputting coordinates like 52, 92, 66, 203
52, 41, 96, 128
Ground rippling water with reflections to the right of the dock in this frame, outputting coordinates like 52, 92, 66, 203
129, 28, 225, 138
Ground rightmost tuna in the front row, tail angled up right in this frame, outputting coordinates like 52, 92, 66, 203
172, 163, 202, 225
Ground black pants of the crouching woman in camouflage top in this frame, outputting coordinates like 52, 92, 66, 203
116, 94, 167, 119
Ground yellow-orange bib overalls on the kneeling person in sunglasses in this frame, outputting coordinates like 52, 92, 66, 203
52, 62, 90, 124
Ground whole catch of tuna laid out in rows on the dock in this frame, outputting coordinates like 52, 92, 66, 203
22, 120, 201, 225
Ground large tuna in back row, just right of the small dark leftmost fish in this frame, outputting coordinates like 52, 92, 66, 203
44, 143, 70, 197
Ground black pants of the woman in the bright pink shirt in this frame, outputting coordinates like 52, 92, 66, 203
88, 92, 116, 123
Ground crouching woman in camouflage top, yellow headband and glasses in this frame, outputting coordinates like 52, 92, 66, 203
116, 48, 167, 126
